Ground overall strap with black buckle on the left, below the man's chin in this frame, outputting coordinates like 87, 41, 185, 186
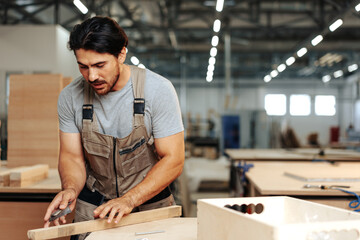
82, 80, 98, 132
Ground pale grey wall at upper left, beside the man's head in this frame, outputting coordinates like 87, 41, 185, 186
0, 25, 79, 151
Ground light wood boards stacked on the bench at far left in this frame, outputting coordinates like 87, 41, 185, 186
0, 164, 49, 187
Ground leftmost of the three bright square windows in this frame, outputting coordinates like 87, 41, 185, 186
265, 94, 286, 116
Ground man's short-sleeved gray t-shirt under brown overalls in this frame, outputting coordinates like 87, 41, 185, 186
58, 69, 184, 138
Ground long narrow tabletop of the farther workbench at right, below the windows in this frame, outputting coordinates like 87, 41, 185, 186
225, 148, 360, 162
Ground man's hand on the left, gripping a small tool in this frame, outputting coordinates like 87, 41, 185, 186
44, 188, 77, 227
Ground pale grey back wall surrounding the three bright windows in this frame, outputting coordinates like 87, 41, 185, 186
173, 80, 354, 145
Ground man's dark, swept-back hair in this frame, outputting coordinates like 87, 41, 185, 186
68, 16, 128, 57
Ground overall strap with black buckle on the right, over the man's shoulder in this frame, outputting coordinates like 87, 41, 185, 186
130, 65, 145, 128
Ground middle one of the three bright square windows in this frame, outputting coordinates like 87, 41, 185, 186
290, 94, 311, 116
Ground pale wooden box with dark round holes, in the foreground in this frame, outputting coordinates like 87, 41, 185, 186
197, 197, 360, 240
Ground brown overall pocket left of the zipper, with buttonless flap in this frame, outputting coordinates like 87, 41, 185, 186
84, 140, 111, 178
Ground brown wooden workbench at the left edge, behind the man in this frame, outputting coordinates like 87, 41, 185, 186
0, 167, 72, 240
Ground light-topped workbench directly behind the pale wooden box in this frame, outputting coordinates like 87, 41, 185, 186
245, 162, 360, 210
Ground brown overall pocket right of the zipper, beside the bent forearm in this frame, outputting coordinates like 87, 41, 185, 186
119, 137, 152, 178
